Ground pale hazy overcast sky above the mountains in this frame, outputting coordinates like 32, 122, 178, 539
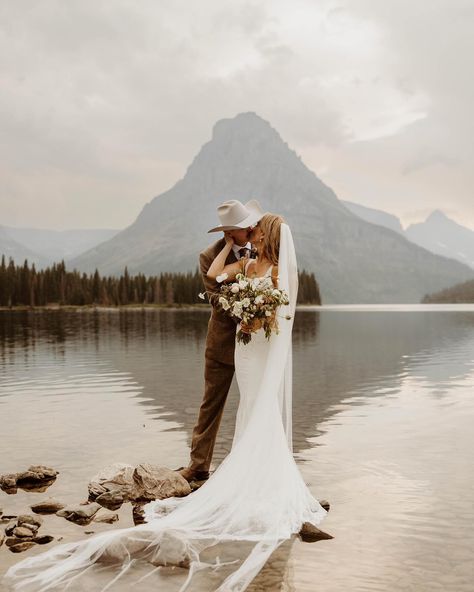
0, 0, 474, 229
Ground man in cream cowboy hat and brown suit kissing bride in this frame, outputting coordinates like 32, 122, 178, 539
178, 199, 264, 482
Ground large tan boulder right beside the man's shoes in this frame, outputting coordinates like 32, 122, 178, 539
132, 463, 191, 501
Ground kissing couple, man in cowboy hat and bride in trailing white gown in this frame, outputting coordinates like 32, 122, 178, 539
6, 200, 332, 592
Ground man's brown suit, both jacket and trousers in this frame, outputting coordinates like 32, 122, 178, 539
189, 238, 243, 471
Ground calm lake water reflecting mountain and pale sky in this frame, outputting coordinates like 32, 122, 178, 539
0, 305, 474, 592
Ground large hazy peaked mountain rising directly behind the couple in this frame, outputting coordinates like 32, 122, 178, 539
48, 113, 471, 303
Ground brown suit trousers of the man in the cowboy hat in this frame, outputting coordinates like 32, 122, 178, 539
189, 357, 234, 471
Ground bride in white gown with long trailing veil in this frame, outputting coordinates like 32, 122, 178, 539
5, 214, 327, 592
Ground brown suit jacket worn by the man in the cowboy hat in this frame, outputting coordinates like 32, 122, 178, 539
199, 238, 241, 366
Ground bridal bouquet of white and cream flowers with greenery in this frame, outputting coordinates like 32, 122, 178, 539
217, 273, 291, 344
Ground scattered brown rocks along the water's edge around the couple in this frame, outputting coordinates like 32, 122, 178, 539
0, 463, 332, 553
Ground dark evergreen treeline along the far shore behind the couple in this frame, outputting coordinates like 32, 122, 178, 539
0, 256, 320, 307
